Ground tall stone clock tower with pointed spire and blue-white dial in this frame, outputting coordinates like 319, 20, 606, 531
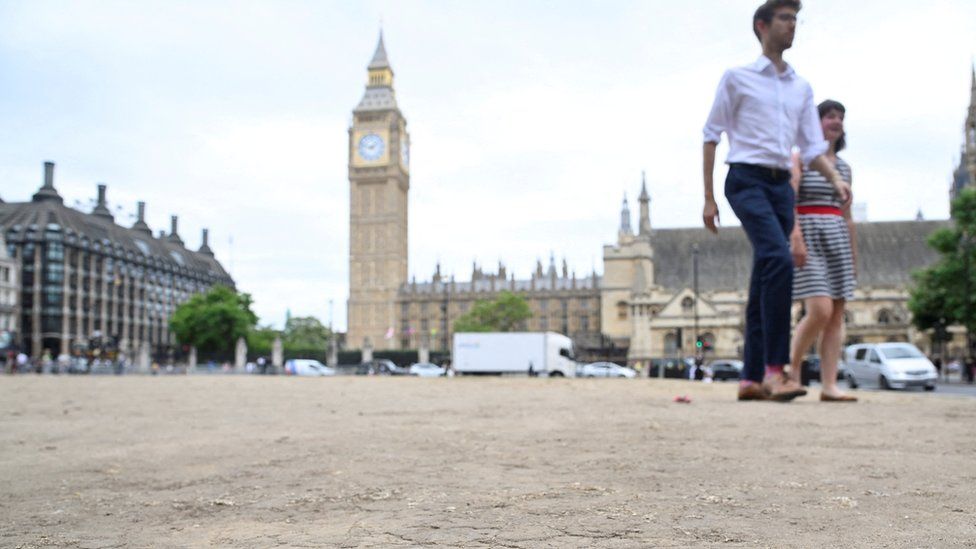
347, 33, 410, 349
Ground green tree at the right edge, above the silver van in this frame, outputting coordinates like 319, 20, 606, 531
908, 189, 976, 352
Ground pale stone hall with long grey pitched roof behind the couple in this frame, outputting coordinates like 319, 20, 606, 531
601, 180, 948, 366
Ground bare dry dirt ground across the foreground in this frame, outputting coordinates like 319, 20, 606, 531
0, 376, 976, 548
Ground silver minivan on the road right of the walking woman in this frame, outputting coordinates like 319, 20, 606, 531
844, 343, 938, 391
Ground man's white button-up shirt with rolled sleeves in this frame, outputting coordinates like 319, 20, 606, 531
704, 55, 828, 170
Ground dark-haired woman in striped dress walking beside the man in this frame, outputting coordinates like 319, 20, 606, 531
790, 100, 857, 402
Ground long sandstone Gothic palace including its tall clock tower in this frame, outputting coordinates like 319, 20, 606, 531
346, 35, 976, 364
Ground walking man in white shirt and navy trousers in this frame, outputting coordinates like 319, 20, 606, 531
702, 0, 851, 401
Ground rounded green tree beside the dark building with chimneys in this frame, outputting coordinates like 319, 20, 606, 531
169, 286, 258, 353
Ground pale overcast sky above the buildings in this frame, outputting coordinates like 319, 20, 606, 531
0, 0, 976, 328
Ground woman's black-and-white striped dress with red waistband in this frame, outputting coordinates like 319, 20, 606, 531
793, 154, 856, 299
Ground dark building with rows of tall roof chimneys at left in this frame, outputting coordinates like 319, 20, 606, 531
0, 162, 234, 357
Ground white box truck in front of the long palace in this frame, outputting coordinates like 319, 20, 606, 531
453, 332, 577, 377
